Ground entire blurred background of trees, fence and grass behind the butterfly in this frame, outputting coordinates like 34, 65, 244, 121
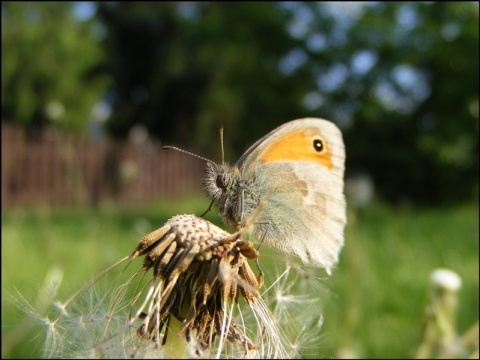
1, 2, 479, 358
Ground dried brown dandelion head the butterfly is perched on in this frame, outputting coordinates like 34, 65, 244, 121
125, 215, 282, 356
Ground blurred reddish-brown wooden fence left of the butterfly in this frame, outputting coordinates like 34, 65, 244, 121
2, 123, 205, 208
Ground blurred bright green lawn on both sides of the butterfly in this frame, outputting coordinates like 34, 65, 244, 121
2, 198, 479, 358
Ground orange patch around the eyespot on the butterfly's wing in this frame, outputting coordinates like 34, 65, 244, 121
260, 129, 333, 169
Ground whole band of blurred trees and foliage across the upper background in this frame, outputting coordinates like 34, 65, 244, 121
2, 2, 479, 204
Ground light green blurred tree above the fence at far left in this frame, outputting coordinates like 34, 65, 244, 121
2, 2, 106, 134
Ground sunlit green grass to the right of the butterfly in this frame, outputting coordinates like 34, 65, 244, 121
323, 204, 479, 358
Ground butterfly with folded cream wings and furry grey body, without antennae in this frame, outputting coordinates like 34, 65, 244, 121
204, 118, 346, 272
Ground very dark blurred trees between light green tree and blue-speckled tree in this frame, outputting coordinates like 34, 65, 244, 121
99, 2, 308, 158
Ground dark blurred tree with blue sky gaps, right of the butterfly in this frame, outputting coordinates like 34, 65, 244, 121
319, 2, 479, 203
